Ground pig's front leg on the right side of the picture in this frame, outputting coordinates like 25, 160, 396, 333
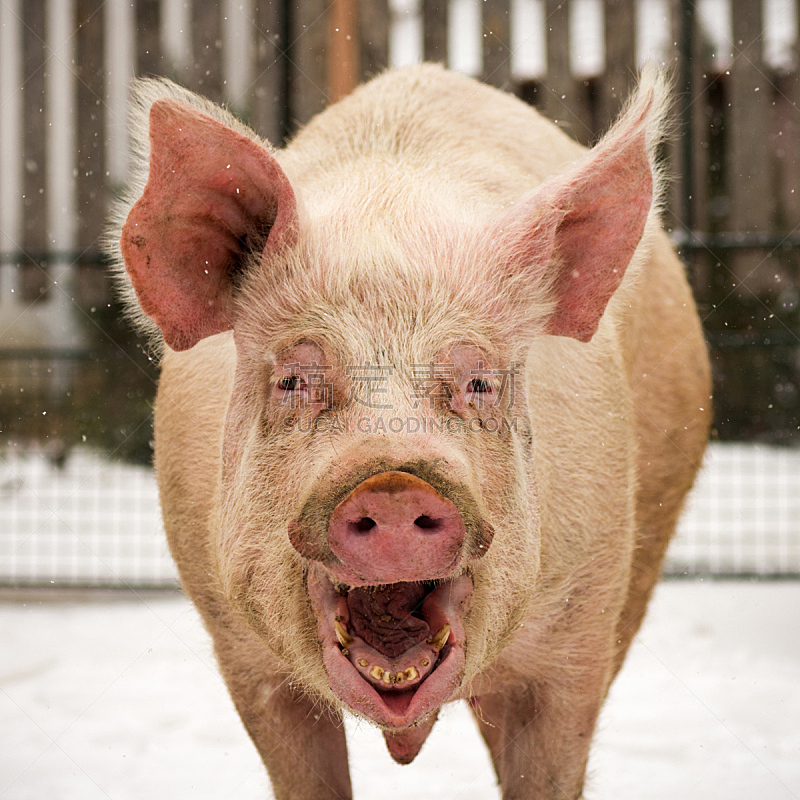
470, 677, 604, 800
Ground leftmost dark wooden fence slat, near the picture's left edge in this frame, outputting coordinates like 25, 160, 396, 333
20, 0, 49, 300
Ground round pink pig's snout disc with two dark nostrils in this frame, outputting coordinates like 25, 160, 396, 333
328, 472, 466, 583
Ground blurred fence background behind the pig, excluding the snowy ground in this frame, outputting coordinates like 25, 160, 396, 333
0, 0, 800, 587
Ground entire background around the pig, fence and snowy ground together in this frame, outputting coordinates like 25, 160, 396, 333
0, 0, 800, 800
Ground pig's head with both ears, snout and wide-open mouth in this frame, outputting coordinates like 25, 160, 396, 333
111, 72, 658, 740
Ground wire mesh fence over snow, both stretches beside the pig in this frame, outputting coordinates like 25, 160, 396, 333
0, 442, 800, 587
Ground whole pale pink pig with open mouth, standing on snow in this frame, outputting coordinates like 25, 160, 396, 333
110, 65, 710, 800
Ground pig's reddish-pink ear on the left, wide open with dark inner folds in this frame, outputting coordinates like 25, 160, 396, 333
120, 99, 297, 350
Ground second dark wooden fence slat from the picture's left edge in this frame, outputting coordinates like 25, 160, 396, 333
75, 0, 107, 304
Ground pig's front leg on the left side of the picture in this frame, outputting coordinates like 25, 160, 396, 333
212, 642, 353, 800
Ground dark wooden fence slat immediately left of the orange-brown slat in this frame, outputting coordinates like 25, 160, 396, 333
289, 0, 328, 127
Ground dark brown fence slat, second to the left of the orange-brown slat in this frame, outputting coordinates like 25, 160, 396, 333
251, 3, 289, 147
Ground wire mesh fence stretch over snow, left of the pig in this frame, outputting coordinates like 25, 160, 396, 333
0, 448, 176, 587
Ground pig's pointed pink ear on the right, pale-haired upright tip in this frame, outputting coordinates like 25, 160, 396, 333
493, 80, 665, 342
